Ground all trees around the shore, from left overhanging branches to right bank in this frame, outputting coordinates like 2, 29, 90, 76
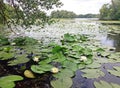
0, 0, 120, 26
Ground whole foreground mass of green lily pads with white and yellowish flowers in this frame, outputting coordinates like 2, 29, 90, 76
0, 33, 120, 88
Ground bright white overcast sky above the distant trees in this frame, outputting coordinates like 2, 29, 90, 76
48, 0, 111, 15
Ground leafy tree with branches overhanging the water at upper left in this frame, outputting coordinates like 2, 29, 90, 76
0, 0, 62, 26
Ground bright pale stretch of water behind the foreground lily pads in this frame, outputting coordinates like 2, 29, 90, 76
24, 18, 120, 51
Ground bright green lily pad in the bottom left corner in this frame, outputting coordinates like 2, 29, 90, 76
0, 75, 23, 88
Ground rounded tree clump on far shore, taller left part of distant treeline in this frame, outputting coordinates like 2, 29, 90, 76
51, 10, 76, 18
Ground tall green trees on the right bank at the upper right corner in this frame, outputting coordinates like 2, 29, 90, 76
100, 0, 120, 20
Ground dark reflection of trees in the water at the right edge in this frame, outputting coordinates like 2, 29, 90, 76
107, 34, 120, 51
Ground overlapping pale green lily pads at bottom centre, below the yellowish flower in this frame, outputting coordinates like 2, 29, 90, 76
51, 69, 74, 88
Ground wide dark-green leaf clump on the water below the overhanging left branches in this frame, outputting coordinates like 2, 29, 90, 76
13, 37, 38, 46
